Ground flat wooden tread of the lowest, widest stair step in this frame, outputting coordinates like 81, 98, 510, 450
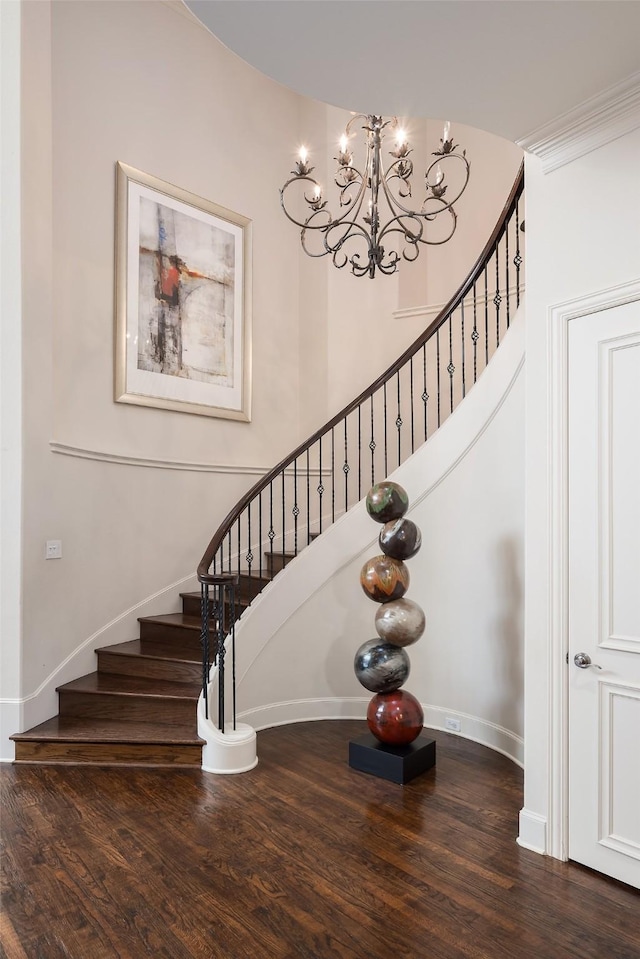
11, 716, 204, 746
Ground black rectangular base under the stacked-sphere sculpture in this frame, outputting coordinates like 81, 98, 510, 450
349, 733, 436, 784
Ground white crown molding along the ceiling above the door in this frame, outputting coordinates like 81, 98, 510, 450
516, 73, 640, 173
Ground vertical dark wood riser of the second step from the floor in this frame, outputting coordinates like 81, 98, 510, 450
58, 691, 197, 730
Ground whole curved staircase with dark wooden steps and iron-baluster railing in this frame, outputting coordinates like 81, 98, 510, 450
11, 163, 524, 768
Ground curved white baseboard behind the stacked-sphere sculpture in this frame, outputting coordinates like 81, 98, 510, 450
238, 696, 524, 766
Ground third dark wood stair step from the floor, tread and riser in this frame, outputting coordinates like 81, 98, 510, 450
96, 639, 202, 683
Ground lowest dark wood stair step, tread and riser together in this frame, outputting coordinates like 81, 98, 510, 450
11, 716, 203, 767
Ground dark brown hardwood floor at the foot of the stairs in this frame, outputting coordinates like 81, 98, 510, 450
0, 722, 640, 959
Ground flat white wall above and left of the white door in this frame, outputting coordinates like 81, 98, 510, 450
520, 130, 640, 851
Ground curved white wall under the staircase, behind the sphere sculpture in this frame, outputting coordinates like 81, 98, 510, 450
236, 316, 525, 760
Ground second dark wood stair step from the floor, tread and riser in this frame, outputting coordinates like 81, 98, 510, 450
57, 672, 200, 726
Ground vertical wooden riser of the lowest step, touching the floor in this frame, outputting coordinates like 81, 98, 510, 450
15, 742, 202, 767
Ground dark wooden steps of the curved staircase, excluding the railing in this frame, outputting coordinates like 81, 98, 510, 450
11, 568, 278, 768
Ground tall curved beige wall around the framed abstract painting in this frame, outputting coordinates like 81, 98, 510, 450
0, 0, 514, 756
